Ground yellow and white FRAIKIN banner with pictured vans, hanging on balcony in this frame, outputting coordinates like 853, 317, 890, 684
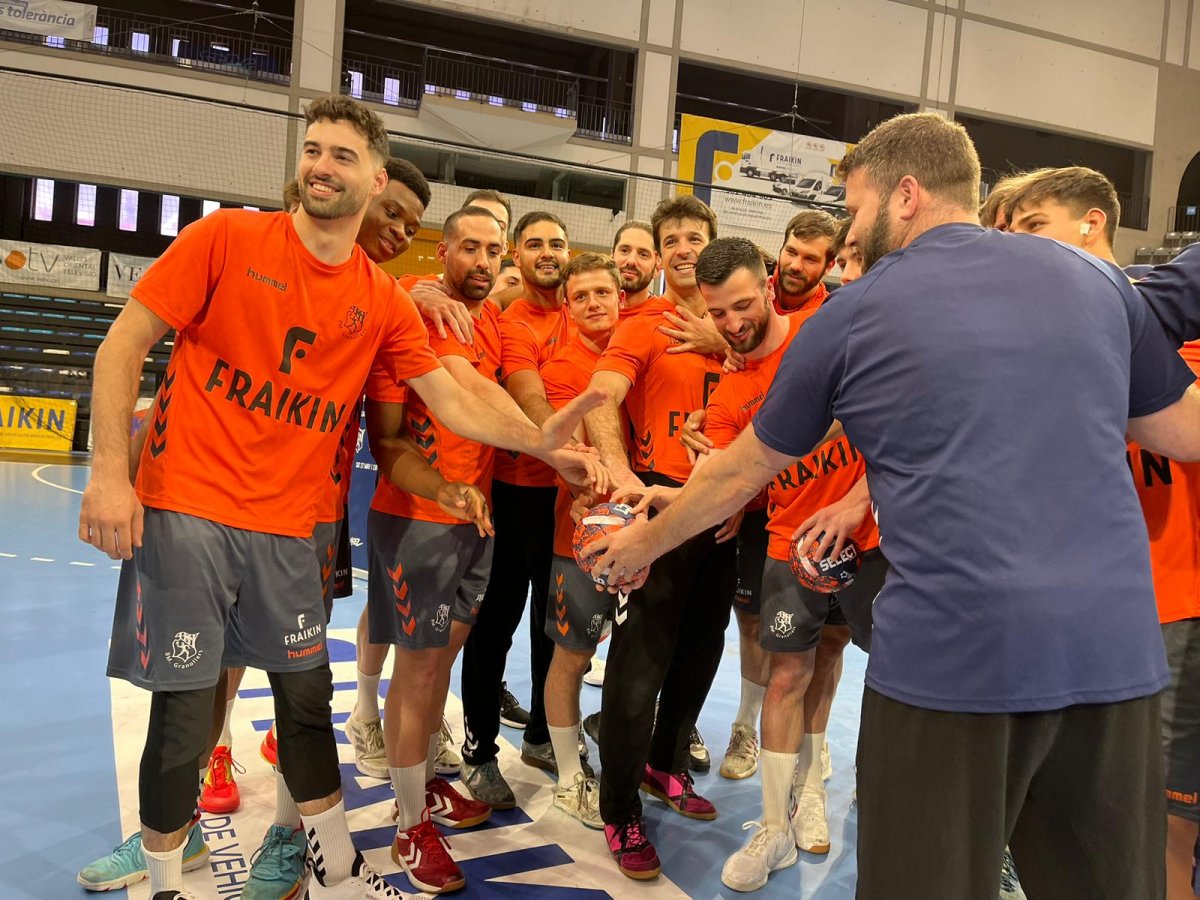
679, 115, 853, 232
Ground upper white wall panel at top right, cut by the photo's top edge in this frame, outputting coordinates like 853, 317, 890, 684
964, 0, 1164, 59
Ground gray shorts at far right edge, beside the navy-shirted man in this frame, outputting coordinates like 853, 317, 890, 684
1163, 619, 1200, 822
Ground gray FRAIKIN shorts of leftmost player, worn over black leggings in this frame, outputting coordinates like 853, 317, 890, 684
108, 506, 328, 691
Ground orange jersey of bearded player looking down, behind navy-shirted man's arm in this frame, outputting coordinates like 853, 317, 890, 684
704, 310, 880, 560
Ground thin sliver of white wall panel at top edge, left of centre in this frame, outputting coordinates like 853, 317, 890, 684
398, 0, 642, 42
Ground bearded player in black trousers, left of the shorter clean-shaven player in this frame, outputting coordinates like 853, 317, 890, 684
453, 212, 571, 809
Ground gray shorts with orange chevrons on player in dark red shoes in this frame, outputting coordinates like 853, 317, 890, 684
367, 510, 492, 650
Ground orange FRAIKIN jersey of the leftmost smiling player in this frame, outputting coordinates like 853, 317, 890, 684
132, 210, 439, 536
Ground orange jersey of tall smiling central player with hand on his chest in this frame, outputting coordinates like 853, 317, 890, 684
595, 298, 721, 484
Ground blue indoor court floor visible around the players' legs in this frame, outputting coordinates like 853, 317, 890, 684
0, 461, 865, 900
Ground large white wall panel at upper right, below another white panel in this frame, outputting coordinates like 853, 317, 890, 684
955, 22, 1158, 144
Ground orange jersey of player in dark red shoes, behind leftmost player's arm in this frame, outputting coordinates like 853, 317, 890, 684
367, 292, 500, 524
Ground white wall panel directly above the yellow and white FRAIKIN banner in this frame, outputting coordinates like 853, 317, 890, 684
680, 0, 926, 96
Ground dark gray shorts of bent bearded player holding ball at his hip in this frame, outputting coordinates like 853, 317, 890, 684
758, 550, 888, 653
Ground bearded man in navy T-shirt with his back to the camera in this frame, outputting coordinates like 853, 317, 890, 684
599, 113, 1200, 900
